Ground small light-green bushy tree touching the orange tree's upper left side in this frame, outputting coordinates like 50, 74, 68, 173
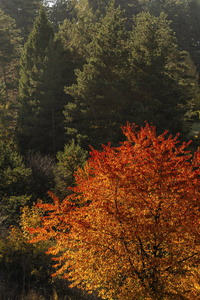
54, 140, 87, 199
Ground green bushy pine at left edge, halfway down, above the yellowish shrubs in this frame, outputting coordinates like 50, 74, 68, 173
0, 141, 31, 226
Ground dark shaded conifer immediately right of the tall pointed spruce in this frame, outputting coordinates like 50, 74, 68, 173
31, 37, 73, 156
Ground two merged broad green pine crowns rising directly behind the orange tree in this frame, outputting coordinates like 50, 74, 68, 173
64, 7, 196, 148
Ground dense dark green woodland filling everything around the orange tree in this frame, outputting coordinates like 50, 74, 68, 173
0, 0, 200, 300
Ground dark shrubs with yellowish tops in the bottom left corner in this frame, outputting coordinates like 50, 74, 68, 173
0, 221, 51, 299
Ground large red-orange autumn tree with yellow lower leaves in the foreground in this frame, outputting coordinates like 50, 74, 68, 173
31, 123, 200, 300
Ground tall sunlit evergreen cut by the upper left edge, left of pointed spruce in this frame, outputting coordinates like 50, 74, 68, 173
0, 10, 21, 140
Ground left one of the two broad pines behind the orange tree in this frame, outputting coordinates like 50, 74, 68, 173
65, 2, 130, 148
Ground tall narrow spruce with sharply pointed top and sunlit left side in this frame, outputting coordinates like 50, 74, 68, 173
17, 7, 54, 155
